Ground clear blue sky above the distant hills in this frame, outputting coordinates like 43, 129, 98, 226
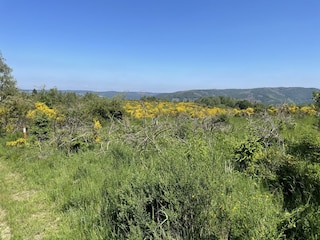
0, 0, 320, 92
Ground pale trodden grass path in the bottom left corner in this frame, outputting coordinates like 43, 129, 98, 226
0, 153, 59, 239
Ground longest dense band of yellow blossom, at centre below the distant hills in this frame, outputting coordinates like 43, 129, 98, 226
124, 101, 228, 118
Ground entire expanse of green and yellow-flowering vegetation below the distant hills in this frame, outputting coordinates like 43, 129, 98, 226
0, 53, 320, 239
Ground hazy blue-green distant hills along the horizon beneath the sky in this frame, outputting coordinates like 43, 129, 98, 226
28, 87, 320, 104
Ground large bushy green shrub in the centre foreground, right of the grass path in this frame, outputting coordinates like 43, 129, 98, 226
99, 136, 281, 239
